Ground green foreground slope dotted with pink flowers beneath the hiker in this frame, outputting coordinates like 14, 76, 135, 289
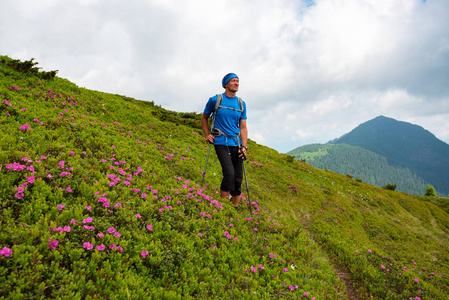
0, 57, 449, 299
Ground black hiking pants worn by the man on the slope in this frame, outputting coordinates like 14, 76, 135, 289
215, 145, 243, 196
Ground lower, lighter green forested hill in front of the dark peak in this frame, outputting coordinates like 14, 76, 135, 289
287, 144, 428, 195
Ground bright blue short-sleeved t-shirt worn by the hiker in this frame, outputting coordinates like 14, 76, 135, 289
204, 93, 246, 146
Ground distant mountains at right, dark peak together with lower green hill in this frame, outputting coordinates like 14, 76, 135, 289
288, 116, 449, 196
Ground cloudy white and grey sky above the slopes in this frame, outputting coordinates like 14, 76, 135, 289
0, 0, 449, 153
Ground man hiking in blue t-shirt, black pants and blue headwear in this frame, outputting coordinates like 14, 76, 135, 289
201, 73, 248, 208
